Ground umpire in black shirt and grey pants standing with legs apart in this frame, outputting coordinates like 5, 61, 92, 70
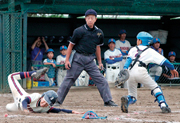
56, 9, 118, 106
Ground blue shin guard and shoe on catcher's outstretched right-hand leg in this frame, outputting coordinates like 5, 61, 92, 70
151, 87, 171, 113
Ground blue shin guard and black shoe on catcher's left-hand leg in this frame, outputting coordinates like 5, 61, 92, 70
121, 95, 137, 113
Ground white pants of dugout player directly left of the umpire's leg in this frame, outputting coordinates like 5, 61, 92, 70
57, 68, 67, 86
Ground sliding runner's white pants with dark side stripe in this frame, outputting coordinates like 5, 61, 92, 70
6, 72, 28, 111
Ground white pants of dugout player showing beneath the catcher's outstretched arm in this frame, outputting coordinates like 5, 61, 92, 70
149, 65, 162, 80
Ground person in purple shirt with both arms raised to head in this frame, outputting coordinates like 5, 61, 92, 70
31, 37, 49, 70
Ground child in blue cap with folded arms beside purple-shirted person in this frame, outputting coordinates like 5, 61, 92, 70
43, 49, 56, 86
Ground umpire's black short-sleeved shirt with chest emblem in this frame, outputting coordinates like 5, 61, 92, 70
70, 24, 104, 54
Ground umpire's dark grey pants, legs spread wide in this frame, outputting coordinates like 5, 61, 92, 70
57, 52, 112, 104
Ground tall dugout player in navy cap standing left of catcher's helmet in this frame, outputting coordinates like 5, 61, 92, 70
116, 29, 131, 88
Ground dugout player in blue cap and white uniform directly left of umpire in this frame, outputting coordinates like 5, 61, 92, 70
56, 46, 67, 86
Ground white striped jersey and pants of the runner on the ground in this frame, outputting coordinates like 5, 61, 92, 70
6, 72, 53, 113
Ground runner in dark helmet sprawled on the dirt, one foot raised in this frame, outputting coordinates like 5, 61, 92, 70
6, 68, 84, 114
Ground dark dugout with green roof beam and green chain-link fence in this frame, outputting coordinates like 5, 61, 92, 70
0, 0, 180, 92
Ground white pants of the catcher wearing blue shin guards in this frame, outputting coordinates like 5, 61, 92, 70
127, 62, 158, 99
